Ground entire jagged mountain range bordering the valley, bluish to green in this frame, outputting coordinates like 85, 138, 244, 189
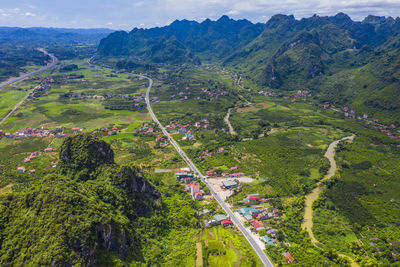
98, 13, 400, 122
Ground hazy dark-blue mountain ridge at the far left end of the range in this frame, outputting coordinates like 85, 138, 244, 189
98, 16, 264, 64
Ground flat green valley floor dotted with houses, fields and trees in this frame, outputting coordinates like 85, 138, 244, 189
0, 57, 400, 266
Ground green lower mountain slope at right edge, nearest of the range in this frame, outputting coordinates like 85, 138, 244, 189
318, 35, 400, 124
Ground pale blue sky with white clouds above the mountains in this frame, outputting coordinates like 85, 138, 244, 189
0, 0, 400, 30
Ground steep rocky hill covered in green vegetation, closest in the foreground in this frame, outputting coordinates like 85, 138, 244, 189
0, 135, 161, 266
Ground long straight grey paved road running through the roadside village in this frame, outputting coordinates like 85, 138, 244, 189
140, 76, 274, 267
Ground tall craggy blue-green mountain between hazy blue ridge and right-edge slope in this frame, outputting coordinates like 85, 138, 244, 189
224, 13, 400, 90
